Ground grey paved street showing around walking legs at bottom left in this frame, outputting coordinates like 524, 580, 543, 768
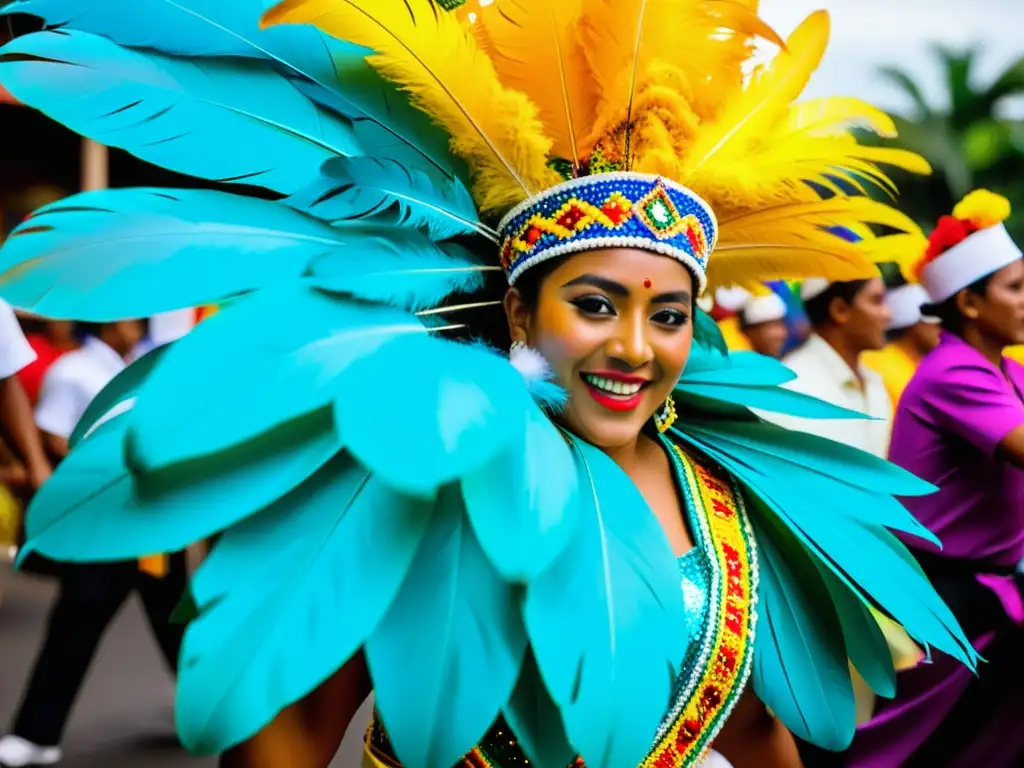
0, 563, 361, 768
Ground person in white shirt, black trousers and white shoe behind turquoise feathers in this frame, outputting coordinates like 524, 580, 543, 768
0, 321, 185, 766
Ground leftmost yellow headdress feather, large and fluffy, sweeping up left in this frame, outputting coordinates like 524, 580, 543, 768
263, 0, 560, 213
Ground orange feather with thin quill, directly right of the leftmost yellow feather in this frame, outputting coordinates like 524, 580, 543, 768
476, 0, 597, 165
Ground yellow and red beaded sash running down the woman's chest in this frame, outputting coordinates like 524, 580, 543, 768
642, 443, 758, 768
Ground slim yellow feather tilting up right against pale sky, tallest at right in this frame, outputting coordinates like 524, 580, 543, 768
679, 11, 828, 183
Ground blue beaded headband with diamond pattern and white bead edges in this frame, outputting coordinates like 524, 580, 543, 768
498, 172, 718, 291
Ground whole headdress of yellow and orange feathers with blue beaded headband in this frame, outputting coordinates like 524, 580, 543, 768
253, 0, 929, 290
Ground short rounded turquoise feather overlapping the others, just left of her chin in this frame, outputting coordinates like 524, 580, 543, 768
334, 334, 535, 497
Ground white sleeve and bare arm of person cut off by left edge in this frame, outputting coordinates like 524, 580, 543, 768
0, 300, 50, 489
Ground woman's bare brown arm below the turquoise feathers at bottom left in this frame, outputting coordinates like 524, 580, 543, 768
220, 651, 371, 768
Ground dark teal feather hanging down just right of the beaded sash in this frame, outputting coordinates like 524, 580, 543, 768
752, 505, 856, 751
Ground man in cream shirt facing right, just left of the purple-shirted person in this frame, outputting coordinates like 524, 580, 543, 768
763, 278, 893, 459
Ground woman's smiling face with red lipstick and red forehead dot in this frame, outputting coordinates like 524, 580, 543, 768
505, 249, 693, 450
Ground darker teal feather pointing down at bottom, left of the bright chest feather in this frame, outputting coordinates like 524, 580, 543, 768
366, 486, 526, 768
